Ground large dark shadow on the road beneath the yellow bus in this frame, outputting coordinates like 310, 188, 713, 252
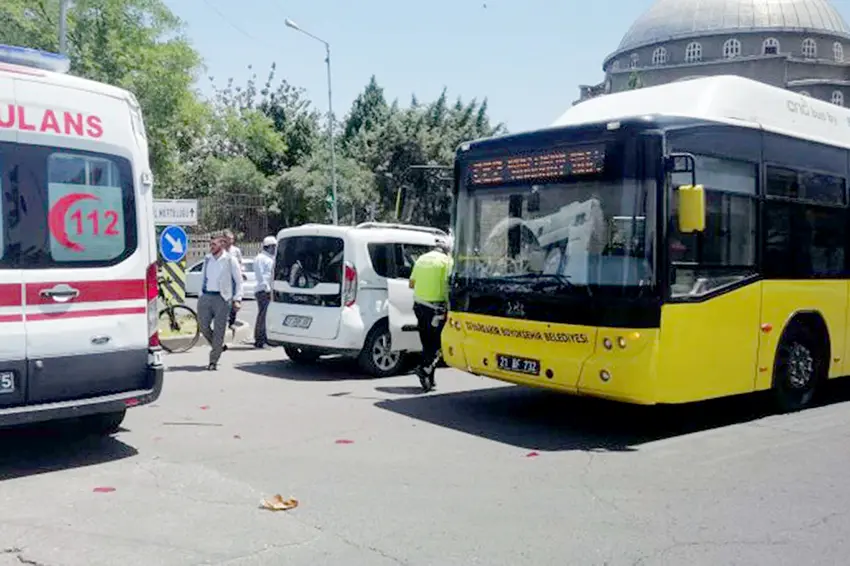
376, 382, 850, 452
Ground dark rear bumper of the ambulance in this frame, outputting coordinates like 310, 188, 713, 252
0, 365, 165, 427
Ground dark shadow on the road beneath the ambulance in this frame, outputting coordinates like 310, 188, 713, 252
0, 423, 138, 480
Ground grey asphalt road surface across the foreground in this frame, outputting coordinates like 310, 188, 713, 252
0, 348, 850, 566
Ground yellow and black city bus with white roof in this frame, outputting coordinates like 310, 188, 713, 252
443, 76, 850, 411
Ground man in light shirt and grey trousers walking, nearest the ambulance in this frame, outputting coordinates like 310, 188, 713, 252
198, 235, 242, 370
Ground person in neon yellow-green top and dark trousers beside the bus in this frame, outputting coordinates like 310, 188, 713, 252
410, 239, 452, 391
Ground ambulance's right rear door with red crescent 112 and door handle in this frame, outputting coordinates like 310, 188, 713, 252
15, 81, 149, 403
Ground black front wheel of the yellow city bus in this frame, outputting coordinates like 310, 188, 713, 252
773, 324, 827, 413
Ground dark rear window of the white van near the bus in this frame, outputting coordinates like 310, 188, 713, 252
275, 236, 345, 288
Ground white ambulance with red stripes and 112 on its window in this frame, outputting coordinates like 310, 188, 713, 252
0, 46, 163, 433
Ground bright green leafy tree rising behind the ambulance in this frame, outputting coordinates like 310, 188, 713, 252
0, 0, 203, 193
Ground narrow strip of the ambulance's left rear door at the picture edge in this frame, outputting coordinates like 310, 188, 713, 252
0, 81, 27, 407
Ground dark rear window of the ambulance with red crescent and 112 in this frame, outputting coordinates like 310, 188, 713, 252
0, 144, 138, 269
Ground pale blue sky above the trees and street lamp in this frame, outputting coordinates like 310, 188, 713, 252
165, 0, 850, 132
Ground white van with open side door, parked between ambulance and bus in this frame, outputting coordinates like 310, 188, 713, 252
266, 223, 448, 377
